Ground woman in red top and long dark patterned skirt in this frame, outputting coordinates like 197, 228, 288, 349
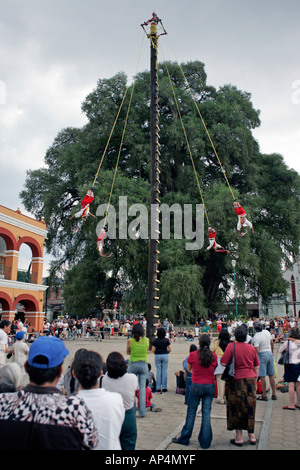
221, 326, 259, 447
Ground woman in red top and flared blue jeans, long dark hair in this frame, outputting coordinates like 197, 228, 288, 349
172, 334, 218, 449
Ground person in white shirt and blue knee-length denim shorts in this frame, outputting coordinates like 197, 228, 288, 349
253, 321, 276, 401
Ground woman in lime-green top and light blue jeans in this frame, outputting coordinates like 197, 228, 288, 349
126, 323, 149, 417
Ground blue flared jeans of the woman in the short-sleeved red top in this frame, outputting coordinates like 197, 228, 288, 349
178, 383, 215, 449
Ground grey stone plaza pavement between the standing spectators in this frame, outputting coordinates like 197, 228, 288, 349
64, 337, 300, 452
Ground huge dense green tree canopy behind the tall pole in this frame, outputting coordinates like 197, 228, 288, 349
20, 61, 300, 321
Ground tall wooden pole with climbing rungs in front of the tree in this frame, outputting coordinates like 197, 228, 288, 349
147, 17, 160, 344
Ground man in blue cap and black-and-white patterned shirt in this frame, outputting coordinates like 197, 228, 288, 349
0, 336, 98, 450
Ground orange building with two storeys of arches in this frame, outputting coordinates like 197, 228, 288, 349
0, 205, 47, 331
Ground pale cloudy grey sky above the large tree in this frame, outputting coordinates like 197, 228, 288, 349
0, 0, 300, 270
